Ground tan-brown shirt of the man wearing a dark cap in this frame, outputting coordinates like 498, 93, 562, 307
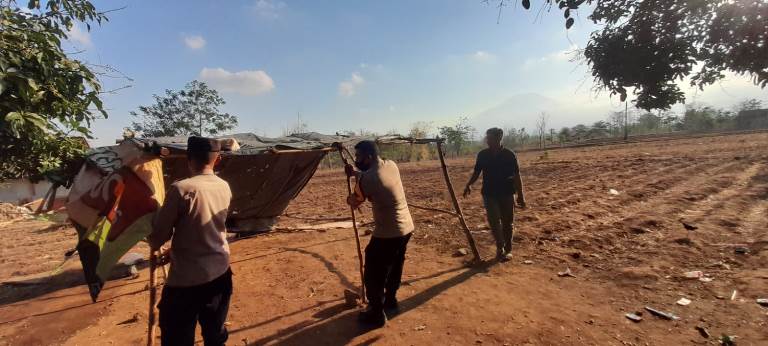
155, 174, 232, 287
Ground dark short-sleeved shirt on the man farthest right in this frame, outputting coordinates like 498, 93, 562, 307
475, 148, 520, 196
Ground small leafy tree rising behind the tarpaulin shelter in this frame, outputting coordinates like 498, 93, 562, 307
131, 80, 237, 137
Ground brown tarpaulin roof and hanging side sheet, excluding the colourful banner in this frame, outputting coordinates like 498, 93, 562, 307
138, 132, 426, 232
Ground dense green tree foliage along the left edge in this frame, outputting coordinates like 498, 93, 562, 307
0, 0, 107, 181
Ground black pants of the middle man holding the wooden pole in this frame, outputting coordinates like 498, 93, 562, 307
363, 233, 411, 309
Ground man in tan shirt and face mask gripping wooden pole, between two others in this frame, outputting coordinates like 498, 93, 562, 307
345, 141, 414, 327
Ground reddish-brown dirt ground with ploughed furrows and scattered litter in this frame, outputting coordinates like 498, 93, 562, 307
0, 133, 768, 345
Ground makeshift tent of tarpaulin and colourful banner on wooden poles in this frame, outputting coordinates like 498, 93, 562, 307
67, 133, 479, 301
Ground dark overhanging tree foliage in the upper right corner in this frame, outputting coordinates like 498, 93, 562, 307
500, 0, 768, 110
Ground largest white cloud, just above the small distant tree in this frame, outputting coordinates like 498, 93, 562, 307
199, 67, 275, 95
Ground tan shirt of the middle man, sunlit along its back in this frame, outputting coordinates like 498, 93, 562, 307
360, 159, 414, 238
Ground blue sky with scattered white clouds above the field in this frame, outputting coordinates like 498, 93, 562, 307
61, 0, 765, 145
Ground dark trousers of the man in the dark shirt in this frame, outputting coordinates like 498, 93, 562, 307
483, 195, 515, 254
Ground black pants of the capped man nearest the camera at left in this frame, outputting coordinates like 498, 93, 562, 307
158, 269, 232, 346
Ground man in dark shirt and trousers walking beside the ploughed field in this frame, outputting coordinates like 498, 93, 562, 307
464, 127, 525, 261
